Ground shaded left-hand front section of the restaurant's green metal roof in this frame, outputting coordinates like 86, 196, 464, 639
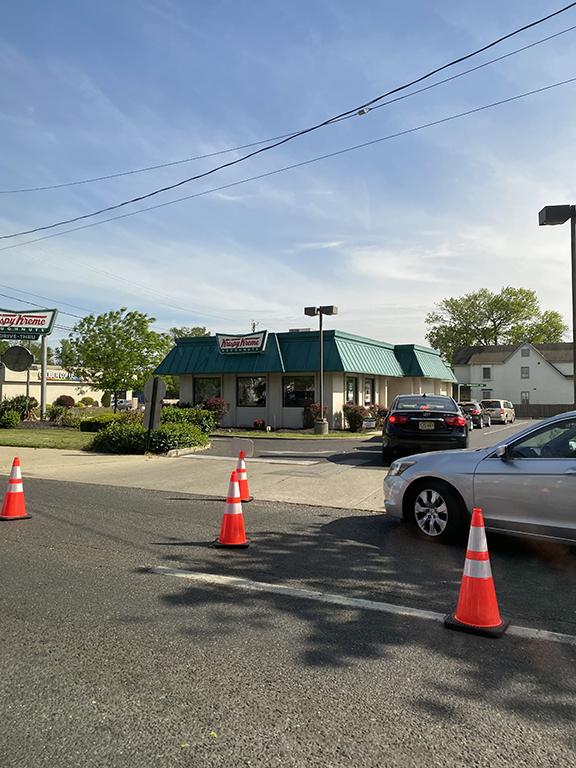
156, 333, 284, 376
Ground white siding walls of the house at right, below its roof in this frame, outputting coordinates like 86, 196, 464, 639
454, 347, 573, 405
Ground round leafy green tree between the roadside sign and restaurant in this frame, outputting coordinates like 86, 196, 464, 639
59, 307, 172, 412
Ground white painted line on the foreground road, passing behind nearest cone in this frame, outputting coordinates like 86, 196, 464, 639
150, 566, 576, 646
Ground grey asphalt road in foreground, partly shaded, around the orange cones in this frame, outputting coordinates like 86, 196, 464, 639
0, 480, 576, 768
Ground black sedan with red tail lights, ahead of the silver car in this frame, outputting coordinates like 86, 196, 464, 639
382, 395, 468, 464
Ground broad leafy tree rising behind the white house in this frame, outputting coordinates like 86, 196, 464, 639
426, 286, 568, 363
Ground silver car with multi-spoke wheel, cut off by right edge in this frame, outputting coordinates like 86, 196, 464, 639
384, 411, 576, 543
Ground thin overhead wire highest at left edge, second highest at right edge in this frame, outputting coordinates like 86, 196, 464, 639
0, 25, 576, 195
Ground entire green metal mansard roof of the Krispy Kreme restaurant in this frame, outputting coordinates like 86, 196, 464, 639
156, 330, 456, 381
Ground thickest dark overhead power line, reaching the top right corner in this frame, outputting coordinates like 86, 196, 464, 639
0, 2, 576, 240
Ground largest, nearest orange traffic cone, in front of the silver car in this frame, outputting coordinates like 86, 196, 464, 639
444, 507, 510, 637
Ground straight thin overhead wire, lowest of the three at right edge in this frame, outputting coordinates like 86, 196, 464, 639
0, 77, 576, 254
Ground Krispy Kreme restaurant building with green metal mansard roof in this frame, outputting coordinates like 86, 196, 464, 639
156, 330, 456, 429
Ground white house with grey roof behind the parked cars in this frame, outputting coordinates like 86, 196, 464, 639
454, 342, 574, 408
